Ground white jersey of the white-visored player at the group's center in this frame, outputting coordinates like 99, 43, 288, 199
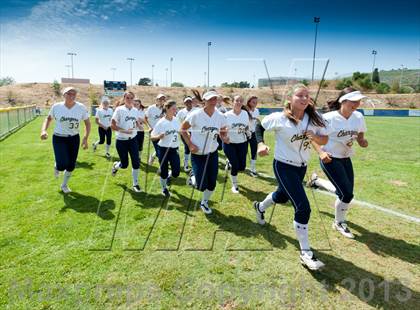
185, 108, 227, 155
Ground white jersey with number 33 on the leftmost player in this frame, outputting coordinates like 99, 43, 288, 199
48, 101, 89, 136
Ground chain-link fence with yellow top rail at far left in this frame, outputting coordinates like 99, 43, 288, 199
0, 105, 40, 139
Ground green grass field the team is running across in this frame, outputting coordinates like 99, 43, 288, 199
0, 117, 420, 309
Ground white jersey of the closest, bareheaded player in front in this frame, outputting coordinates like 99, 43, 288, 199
261, 112, 328, 167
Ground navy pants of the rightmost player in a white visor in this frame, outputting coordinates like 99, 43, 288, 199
320, 158, 354, 203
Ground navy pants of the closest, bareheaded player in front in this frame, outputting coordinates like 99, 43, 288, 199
273, 160, 311, 224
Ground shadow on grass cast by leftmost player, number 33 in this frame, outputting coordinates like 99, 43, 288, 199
60, 192, 115, 220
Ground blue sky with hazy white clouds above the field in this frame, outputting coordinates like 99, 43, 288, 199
0, 0, 420, 86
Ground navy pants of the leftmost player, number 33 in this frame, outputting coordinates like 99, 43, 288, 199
52, 135, 80, 172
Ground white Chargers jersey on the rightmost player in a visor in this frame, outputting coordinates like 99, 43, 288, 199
322, 111, 367, 158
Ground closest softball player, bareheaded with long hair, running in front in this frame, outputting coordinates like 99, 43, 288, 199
254, 84, 328, 270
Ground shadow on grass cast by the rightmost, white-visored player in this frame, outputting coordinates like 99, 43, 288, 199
321, 211, 420, 264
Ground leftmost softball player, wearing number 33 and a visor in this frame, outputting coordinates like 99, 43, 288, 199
41, 87, 91, 194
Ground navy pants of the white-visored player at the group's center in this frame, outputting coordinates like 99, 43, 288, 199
191, 150, 219, 192
